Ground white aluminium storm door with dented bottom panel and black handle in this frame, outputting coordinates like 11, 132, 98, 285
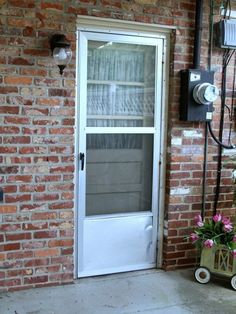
78, 31, 163, 277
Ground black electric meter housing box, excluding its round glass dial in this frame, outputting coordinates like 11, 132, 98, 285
180, 69, 214, 121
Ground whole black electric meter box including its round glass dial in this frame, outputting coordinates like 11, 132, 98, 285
180, 69, 219, 121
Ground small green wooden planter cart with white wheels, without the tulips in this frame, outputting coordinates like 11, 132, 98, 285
194, 245, 236, 290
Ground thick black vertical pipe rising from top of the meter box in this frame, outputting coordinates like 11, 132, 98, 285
193, 0, 203, 69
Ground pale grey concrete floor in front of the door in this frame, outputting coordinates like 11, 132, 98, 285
0, 270, 236, 314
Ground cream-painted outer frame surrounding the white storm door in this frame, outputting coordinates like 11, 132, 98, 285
74, 16, 171, 278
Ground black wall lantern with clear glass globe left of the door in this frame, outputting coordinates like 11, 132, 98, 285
50, 34, 72, 75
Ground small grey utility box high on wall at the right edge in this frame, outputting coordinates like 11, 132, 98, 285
214, 19, 236, 49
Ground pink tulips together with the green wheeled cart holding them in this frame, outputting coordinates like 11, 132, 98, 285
189, 214, 236, 290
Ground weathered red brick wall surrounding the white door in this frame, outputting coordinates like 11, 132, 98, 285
0, 0, 235, 290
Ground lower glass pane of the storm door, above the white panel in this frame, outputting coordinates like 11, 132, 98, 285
86, 134, 153, 216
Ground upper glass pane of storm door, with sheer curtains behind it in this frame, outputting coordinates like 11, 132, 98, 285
87, 41, 156, 127
